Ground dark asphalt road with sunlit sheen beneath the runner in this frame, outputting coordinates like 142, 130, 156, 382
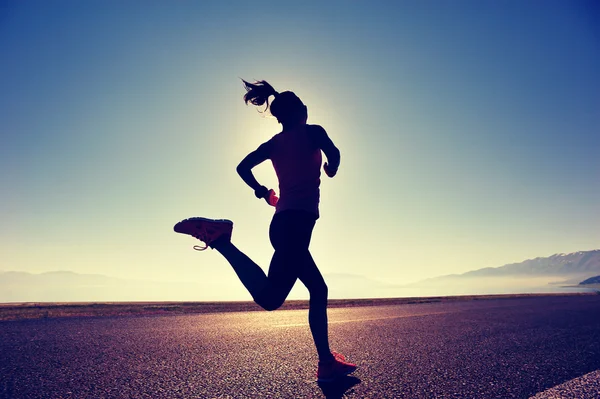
0, 295, 600, 399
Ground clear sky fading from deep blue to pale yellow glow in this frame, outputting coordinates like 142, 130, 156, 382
0, 0, 600, 300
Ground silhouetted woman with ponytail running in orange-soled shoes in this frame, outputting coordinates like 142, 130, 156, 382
175, 80, 356, 381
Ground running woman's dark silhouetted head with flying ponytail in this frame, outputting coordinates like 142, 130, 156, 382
242, 79, 308, 126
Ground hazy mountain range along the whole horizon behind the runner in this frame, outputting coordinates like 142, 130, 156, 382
0, 250, 600, 303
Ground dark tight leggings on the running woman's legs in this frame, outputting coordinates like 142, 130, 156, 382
213, 210, 331, 360
